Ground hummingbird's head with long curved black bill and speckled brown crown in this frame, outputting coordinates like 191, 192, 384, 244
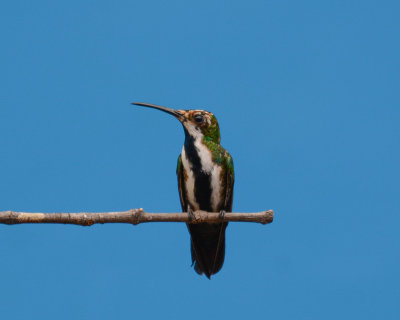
132, 102, 221, 143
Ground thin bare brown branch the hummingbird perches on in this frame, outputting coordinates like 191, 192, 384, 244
0, 209, 274, 226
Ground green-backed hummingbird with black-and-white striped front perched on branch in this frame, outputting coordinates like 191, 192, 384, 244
132, 102, 235, 279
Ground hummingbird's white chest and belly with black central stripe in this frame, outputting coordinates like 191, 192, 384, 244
182, 142, 223, 212
